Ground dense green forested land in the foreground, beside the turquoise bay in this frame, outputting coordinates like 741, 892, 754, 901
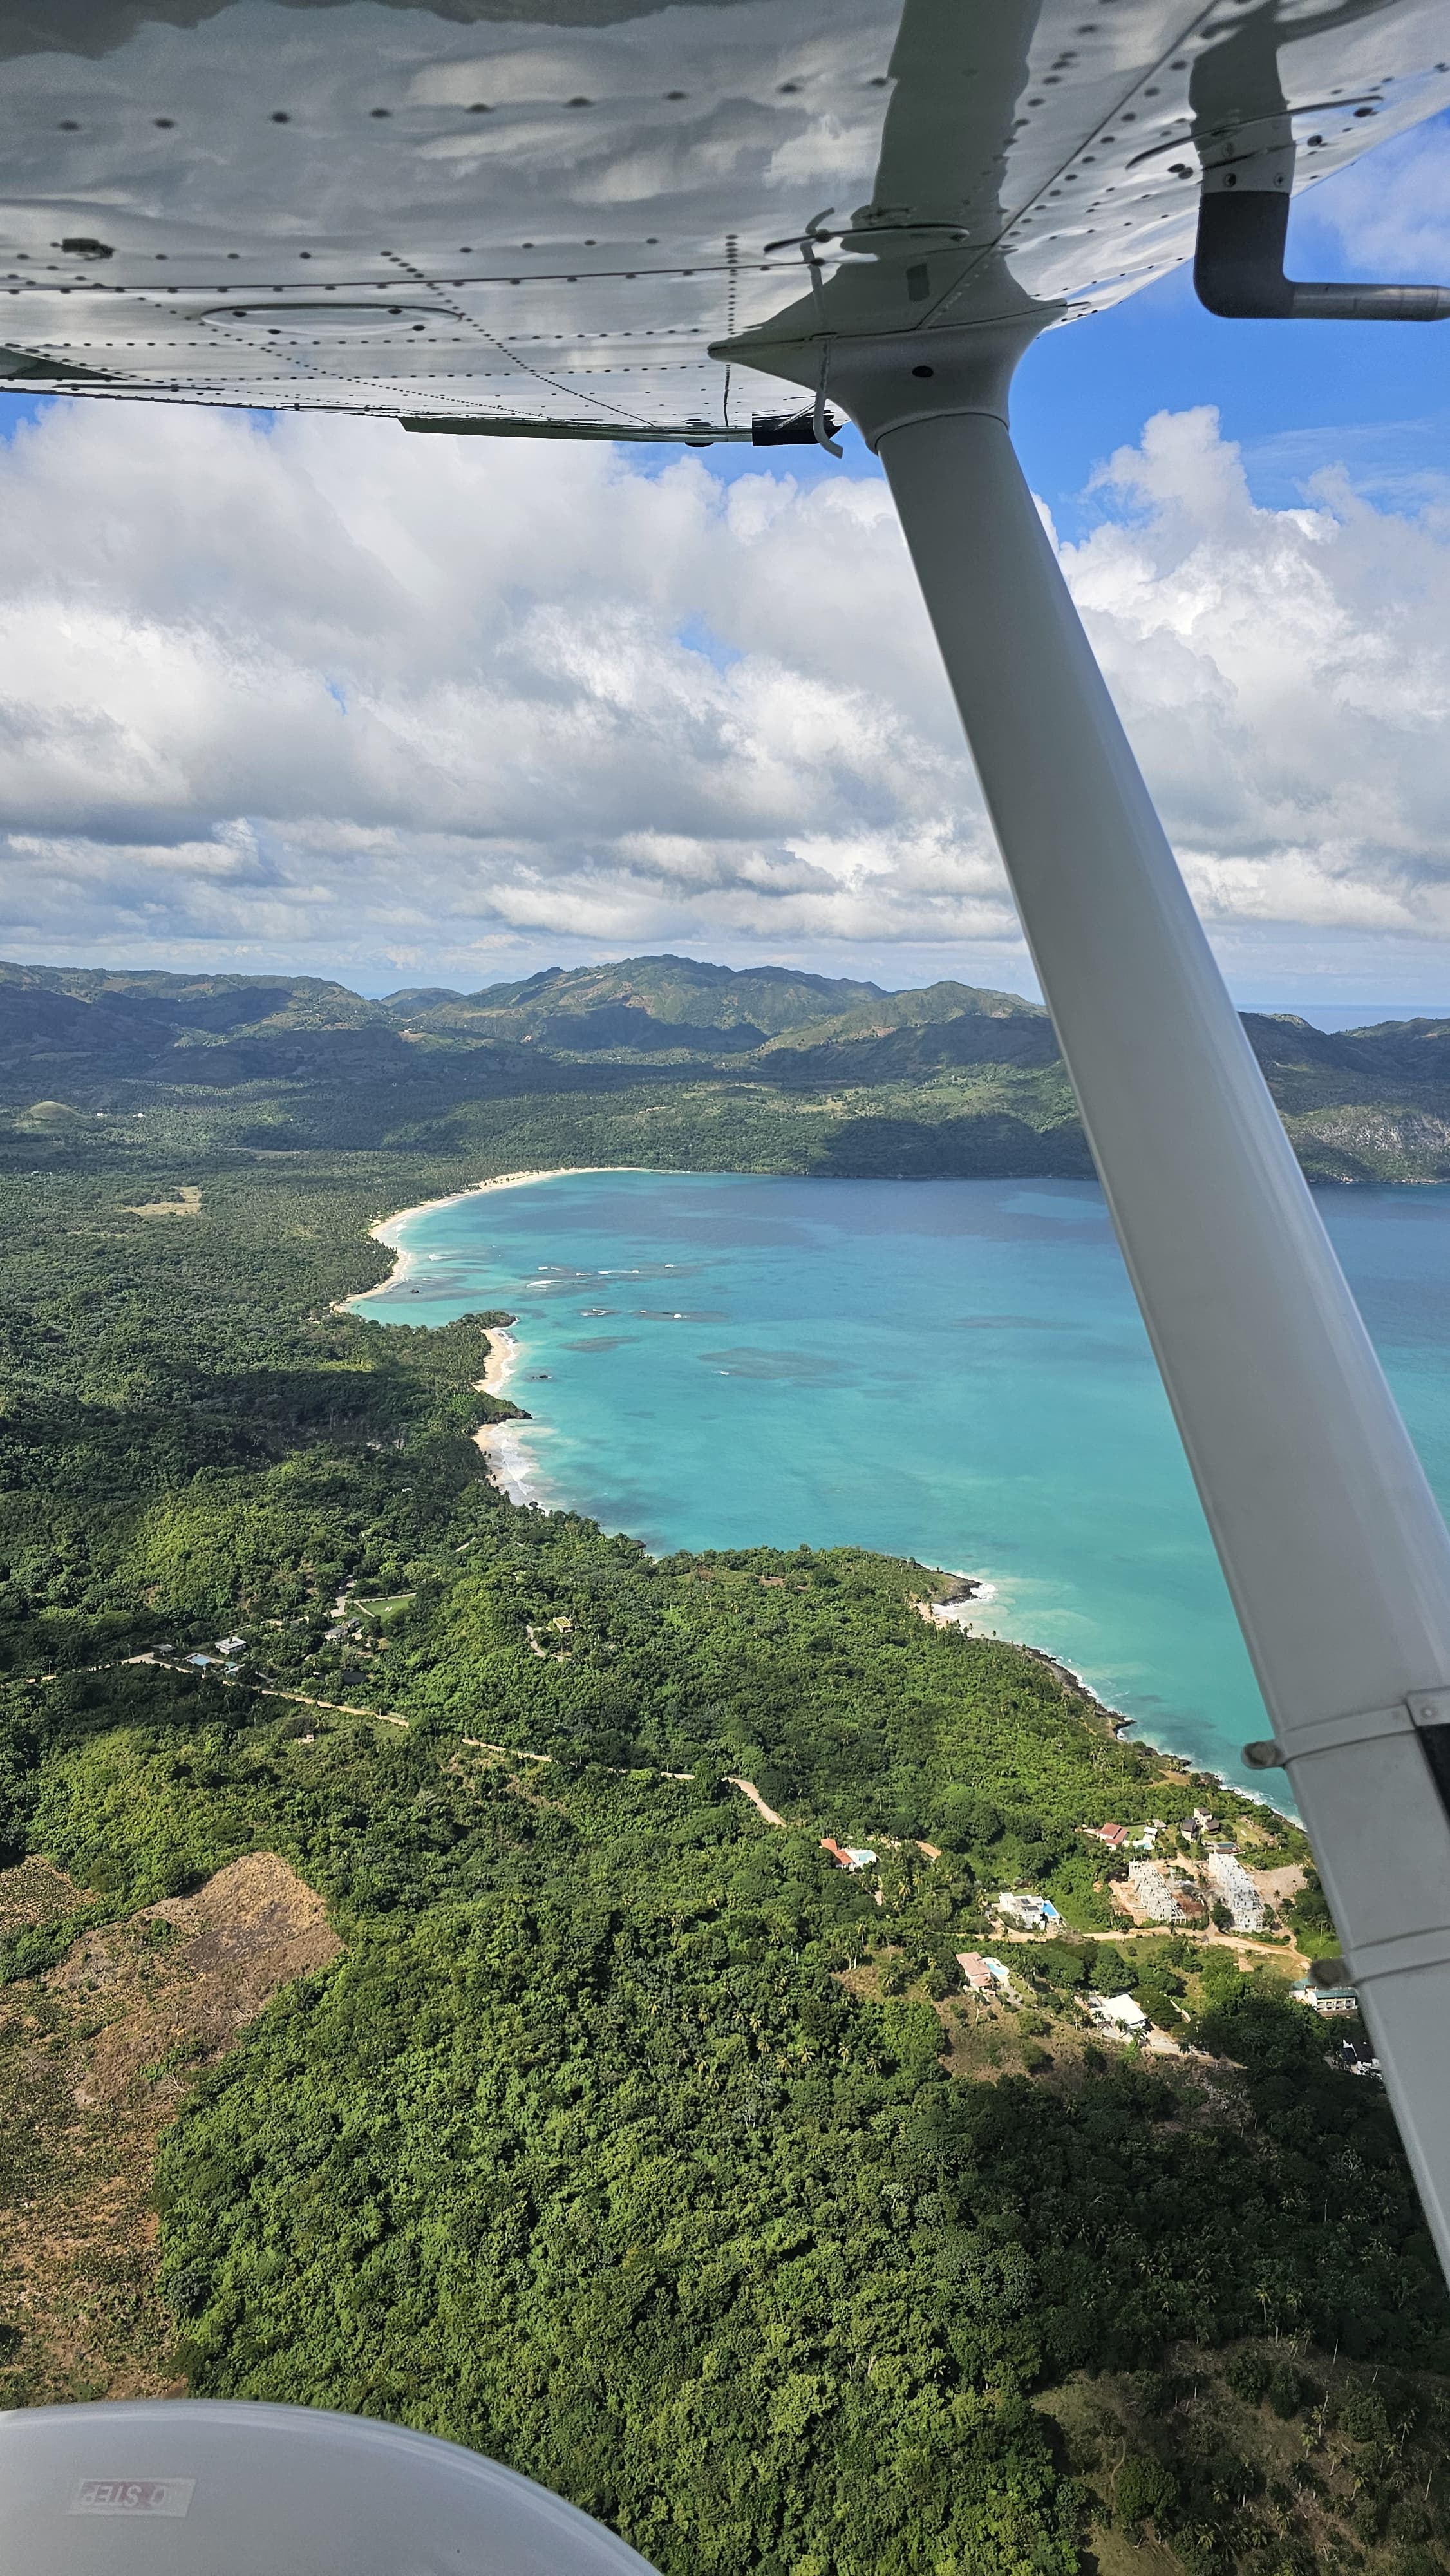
0, 1097, 1450, 2576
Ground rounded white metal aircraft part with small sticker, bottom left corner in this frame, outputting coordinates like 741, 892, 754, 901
0, 2398, 649, 2576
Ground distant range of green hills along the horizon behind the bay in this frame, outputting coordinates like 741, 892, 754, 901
0, 956, 1450, 1185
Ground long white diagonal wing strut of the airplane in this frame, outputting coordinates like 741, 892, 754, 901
824, 322, 1450, 2272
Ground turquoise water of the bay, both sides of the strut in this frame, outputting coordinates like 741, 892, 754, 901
358, 1172, 1450, 1788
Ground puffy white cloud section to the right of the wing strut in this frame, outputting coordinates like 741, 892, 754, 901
1064, 410, 1450, 940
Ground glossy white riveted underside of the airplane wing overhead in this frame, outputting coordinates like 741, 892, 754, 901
0, 0, 1450, 438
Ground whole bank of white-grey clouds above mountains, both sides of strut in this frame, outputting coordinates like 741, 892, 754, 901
0, 404, 1450, 984
